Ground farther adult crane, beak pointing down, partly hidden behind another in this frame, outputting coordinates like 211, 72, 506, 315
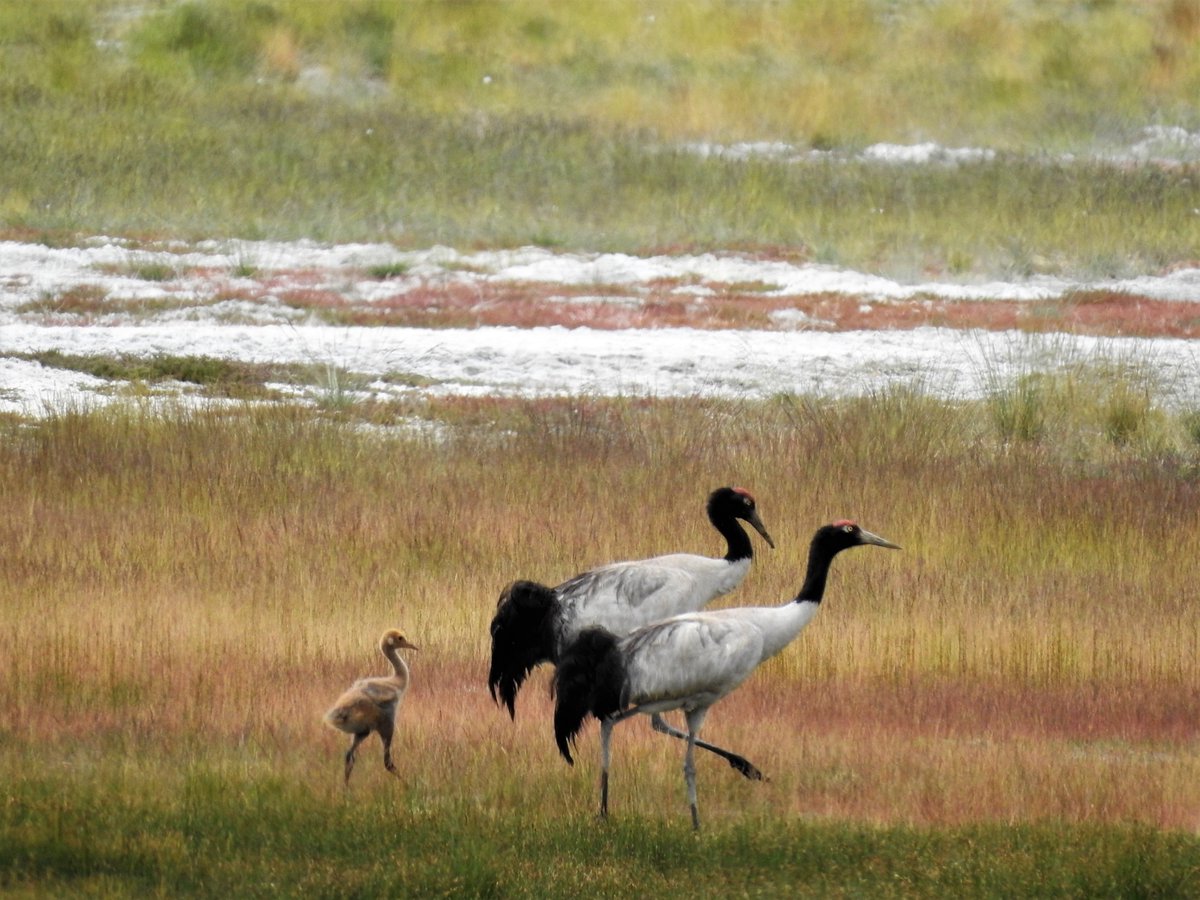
487, 487, 775, 779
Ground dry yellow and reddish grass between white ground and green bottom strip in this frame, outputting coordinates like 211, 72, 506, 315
0, 401, 1200, 829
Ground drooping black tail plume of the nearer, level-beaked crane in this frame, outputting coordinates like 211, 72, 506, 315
553, 628, 625, 766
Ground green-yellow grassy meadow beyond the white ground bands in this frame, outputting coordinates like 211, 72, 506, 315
0, 0, 1200, 277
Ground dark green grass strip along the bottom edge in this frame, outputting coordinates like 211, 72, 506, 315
0, 767, 1200, 898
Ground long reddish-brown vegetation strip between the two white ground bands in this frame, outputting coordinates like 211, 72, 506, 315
247, 272, 1200, 338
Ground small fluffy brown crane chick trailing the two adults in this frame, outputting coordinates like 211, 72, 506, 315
325, 629, 418, 784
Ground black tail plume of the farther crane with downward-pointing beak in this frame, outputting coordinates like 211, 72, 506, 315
487, 581, 558, 719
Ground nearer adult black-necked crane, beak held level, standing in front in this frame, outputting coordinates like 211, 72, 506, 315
554, 520, 900, 829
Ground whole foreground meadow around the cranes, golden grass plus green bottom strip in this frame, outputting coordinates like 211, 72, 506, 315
0, 390, 1200, 896
